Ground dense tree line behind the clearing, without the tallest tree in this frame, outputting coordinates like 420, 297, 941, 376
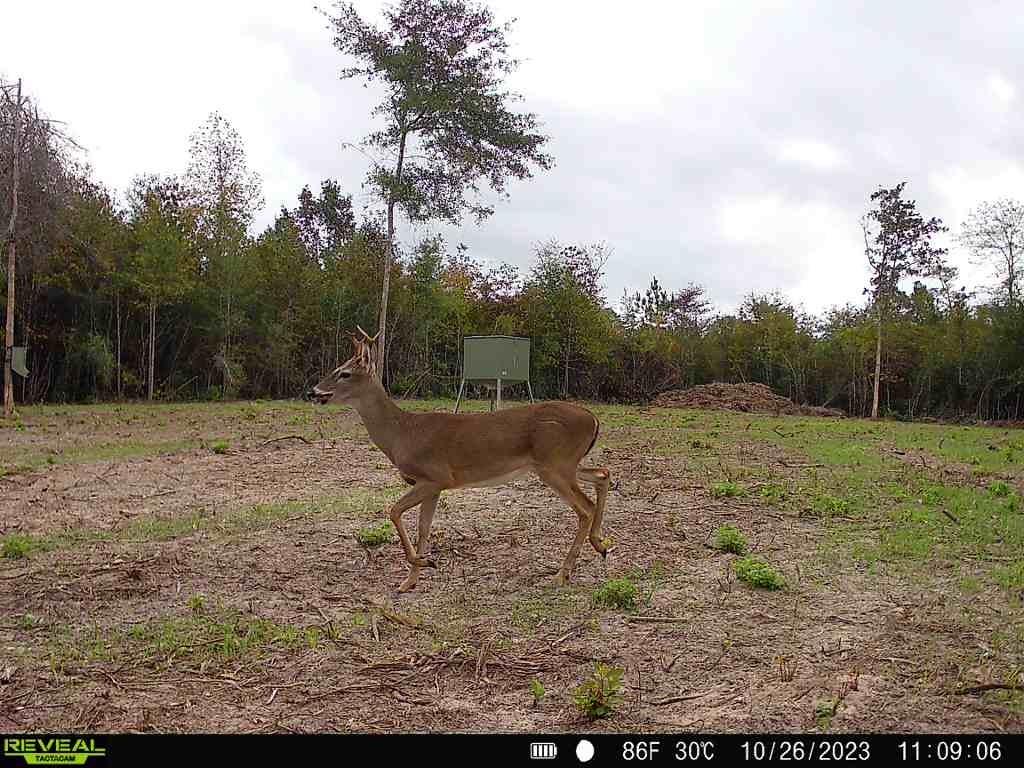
0, 94, 1024, 419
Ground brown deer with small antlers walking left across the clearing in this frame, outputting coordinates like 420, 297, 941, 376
308, 326, 611, 592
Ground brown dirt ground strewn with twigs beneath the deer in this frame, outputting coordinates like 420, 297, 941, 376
0, 404, 1024, 732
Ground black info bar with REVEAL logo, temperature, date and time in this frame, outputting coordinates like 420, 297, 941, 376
0, 733, 1024, 768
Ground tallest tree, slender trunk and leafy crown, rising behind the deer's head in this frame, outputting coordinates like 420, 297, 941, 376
331, 0, 553, 377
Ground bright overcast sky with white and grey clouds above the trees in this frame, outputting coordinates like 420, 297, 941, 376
0, 0, 1024, 311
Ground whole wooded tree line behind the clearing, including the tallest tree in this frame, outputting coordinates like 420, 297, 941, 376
0, 0, 1024, 419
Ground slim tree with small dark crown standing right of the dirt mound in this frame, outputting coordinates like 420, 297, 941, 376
861, 181, 947, 419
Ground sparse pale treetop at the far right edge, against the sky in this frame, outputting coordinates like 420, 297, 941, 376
959, 198, 1024, 307
